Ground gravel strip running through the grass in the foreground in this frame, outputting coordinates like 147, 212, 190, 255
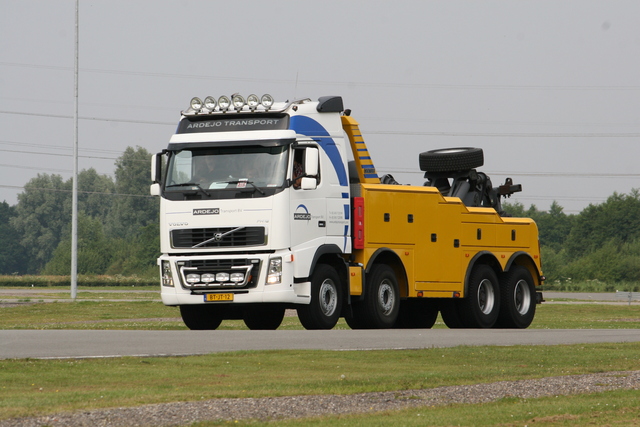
0, 371, 640, 427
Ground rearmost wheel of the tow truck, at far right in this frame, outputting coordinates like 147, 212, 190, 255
494, 265, 536, 329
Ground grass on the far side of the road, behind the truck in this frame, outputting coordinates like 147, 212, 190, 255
0, 298, 640, 330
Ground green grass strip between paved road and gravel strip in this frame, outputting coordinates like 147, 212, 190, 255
0, 343, 640, 419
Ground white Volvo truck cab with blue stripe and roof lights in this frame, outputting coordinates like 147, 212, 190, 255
152, 95, 351, 327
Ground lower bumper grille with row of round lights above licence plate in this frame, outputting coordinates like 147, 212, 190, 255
178, 259, 260, 291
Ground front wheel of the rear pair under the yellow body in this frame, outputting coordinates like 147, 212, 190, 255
459, 264, 500, 328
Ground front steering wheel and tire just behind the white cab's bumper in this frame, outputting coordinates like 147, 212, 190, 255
298, 264, 344, 329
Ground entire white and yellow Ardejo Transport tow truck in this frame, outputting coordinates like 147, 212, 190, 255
151, 94, 544, 329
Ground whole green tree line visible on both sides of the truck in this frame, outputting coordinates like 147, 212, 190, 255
0, 147, 640, 283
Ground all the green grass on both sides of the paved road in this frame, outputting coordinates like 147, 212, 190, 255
0, 287, 640, 427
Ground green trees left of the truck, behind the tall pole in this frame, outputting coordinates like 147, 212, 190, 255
0, 147, 160, 276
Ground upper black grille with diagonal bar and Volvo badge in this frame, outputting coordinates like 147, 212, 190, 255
171, 227, 266, 248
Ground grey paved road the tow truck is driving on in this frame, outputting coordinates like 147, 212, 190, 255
0, 329, 640, 359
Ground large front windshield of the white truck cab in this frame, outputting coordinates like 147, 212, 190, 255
165, 145, 288, 198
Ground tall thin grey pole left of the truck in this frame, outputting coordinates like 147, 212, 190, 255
71, 0, 80, 301
